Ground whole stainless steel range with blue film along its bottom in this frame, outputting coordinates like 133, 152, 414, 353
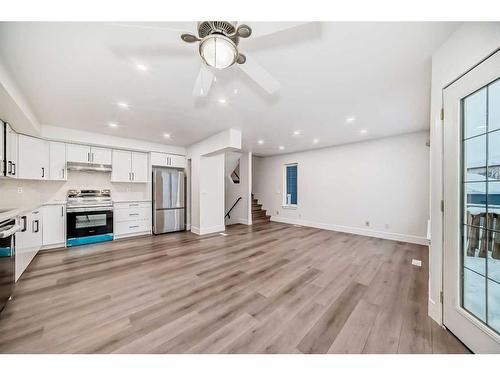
66, 189, 113, 247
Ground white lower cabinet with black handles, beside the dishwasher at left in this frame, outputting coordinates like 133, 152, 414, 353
16, 209, 43, 281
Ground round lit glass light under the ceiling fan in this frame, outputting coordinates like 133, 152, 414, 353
200, 33, 238, 69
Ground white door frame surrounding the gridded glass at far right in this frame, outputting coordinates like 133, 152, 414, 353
443, 51, 500, 353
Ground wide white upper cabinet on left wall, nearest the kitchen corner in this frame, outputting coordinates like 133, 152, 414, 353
17, 134, 49, 180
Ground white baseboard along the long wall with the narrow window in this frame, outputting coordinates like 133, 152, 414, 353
271, 216, 429, 245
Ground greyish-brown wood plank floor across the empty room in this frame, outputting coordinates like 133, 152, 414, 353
0, 222, 468, 353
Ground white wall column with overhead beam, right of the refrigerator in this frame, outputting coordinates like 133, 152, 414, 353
187, 129, 241, 234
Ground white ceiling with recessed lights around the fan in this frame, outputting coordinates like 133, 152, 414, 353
0, 22, 458, 155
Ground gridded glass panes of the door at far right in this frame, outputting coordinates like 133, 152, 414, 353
461, 80, 500, 333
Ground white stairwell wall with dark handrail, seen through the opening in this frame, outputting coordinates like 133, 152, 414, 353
224, 152, 252, 225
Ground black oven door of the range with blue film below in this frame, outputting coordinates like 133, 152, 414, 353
66, 207, 113, 246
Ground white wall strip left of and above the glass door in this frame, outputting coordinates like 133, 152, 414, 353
429, 22, 500, 324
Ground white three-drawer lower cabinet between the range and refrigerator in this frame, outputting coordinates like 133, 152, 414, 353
113, 202, 151, 239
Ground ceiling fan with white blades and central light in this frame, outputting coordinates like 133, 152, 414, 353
110, 21, 303, 97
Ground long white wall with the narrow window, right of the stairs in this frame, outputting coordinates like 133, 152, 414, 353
253, 132, 429, 244
